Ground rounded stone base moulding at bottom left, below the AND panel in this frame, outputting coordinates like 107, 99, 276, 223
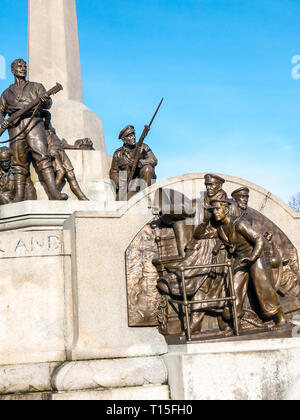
0, 357, 169, 401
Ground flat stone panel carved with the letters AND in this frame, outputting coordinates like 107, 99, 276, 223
0, 231, 70, 365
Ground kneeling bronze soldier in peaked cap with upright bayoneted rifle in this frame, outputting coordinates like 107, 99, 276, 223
109, 99, 163, 201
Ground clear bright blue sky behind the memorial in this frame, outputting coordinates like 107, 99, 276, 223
0, 0, 300, 202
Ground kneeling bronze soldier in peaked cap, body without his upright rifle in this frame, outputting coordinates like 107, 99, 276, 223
109, 125, 157, 200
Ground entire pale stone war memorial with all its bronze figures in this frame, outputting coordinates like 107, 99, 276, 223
0, 0, 300, 401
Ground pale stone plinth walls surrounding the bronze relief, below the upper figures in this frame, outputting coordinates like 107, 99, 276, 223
0, 174, 300, 400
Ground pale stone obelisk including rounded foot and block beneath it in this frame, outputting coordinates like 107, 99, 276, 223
28, 0, 114, 201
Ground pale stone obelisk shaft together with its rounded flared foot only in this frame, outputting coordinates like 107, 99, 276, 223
28, 0, 107, 162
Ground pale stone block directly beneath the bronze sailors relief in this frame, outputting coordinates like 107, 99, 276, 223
164, 338, 300, 400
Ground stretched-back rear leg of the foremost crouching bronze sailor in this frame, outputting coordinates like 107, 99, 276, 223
250, 258, 286, 325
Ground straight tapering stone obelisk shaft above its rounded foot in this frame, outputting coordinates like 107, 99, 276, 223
28, 0, 83, 103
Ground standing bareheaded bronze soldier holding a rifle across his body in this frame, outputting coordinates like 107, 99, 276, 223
0, 59, 68, 202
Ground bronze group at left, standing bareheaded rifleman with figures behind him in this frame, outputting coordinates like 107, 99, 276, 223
0, 59, 93, 204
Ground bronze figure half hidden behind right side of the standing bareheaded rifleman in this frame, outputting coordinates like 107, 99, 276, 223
41, 110, 91, 201
